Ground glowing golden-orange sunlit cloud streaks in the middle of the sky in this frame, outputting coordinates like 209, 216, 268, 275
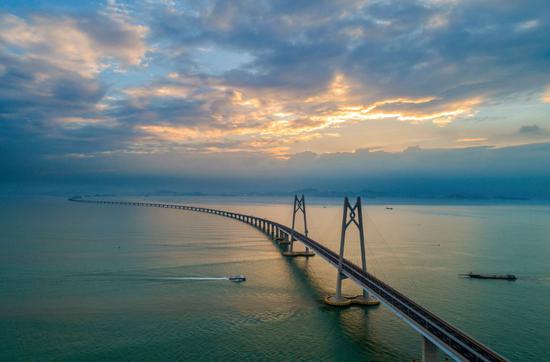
125, 74, 488, 156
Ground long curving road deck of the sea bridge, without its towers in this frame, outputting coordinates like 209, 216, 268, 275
69, 197, 506, 361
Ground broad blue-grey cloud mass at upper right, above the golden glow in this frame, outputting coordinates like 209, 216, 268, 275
141, 1, 550, 124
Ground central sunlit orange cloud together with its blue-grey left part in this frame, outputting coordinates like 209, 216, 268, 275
104, 73, 488, 157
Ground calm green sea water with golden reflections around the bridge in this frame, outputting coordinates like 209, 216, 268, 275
0, 196, 550, 361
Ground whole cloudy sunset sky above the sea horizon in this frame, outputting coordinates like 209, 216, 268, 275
0, 0, 550, 198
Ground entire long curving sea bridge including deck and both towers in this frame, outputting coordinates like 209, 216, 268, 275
69, 195, 506, 362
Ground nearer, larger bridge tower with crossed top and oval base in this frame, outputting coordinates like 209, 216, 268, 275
325, 197, 380, 307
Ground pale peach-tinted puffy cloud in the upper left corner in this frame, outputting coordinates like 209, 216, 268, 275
0, 14, 147, 78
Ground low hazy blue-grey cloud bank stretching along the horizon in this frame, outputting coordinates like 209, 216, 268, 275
4, 139, 550, 198
